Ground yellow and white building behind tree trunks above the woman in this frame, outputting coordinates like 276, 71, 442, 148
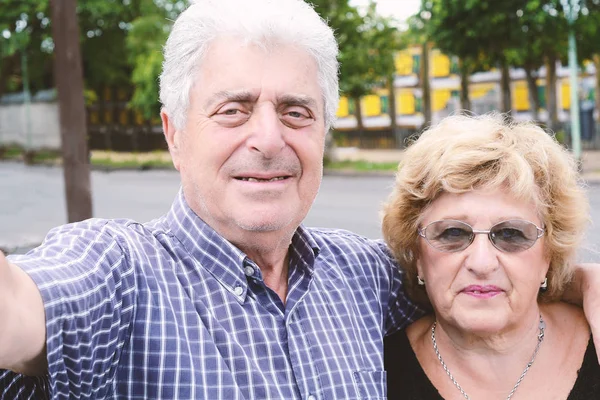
336, 47, 588, 130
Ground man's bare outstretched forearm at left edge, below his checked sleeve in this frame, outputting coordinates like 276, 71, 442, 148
0, 251, 48, 375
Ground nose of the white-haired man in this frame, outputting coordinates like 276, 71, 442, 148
247, 105, 285, 158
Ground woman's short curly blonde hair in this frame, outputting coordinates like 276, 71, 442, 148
383, 113, 589, 304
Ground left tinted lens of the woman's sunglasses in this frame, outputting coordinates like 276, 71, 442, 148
424, 220, 473, 253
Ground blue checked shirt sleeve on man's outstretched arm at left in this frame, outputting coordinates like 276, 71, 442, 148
9, 220, 135, 399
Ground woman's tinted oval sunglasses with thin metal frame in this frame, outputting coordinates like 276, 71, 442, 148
418, 219, 544, 253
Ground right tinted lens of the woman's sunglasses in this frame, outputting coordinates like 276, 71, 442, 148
490, 220, 538, 253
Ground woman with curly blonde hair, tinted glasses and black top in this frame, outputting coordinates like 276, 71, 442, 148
383, 115, 600, 400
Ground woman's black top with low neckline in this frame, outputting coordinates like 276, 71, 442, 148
383, 331, 600, 400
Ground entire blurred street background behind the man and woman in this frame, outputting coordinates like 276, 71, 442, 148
0, 0, 600, 260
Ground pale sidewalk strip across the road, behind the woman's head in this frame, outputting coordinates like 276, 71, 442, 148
334, 147, 600, 183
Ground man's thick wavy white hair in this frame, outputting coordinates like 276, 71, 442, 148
160, 0, 339, 129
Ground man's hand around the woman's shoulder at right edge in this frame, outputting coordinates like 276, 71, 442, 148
563, 264, 600, 363
